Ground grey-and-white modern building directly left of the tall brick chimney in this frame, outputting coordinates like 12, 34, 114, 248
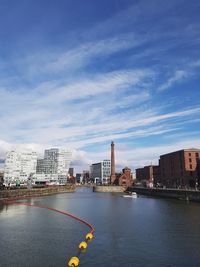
90, 159, 111, 184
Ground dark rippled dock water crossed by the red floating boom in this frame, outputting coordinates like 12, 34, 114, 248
0, 188, 200, 267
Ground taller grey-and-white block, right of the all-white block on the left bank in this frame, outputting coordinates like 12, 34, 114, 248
35, 148, 72, 184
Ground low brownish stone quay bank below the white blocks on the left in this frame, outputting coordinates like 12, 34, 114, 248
0, 185, 76, 200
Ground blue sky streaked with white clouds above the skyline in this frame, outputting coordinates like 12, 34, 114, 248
0, 0, 200, 172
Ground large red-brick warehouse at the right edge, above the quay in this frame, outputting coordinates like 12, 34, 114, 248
159, 148, 200, 188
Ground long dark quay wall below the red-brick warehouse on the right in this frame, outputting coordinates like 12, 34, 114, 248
127, 187, 200, 202
